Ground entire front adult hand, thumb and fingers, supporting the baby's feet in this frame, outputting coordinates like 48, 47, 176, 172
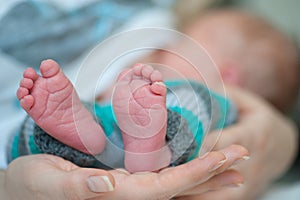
0, 145, 248, 200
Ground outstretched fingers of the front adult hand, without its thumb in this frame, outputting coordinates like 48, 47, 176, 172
99, 145, 248, 200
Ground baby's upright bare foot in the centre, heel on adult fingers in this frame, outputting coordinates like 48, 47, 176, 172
112, 64, 171, 172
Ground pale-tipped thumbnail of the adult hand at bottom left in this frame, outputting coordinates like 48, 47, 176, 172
86, 176, 114, 193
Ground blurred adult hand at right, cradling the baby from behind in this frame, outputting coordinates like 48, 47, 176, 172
176, 88, 298, 200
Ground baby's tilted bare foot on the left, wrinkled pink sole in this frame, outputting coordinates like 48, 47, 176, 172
17, 60, 105, 154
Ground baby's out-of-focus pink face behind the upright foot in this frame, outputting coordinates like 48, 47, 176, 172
152, 16, 239, 89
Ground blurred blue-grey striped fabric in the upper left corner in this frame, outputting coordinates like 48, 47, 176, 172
0, 0, 155, 67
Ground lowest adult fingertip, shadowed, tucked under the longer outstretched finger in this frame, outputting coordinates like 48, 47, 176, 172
176, 170, 244, 199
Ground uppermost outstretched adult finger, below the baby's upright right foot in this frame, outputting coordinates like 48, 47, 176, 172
154, 145, 248, 196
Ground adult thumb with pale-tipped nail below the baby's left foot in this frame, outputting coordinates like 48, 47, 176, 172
61, 168, 115, 199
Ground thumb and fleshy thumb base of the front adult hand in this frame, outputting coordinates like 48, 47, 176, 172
0, 154, 114, 200
